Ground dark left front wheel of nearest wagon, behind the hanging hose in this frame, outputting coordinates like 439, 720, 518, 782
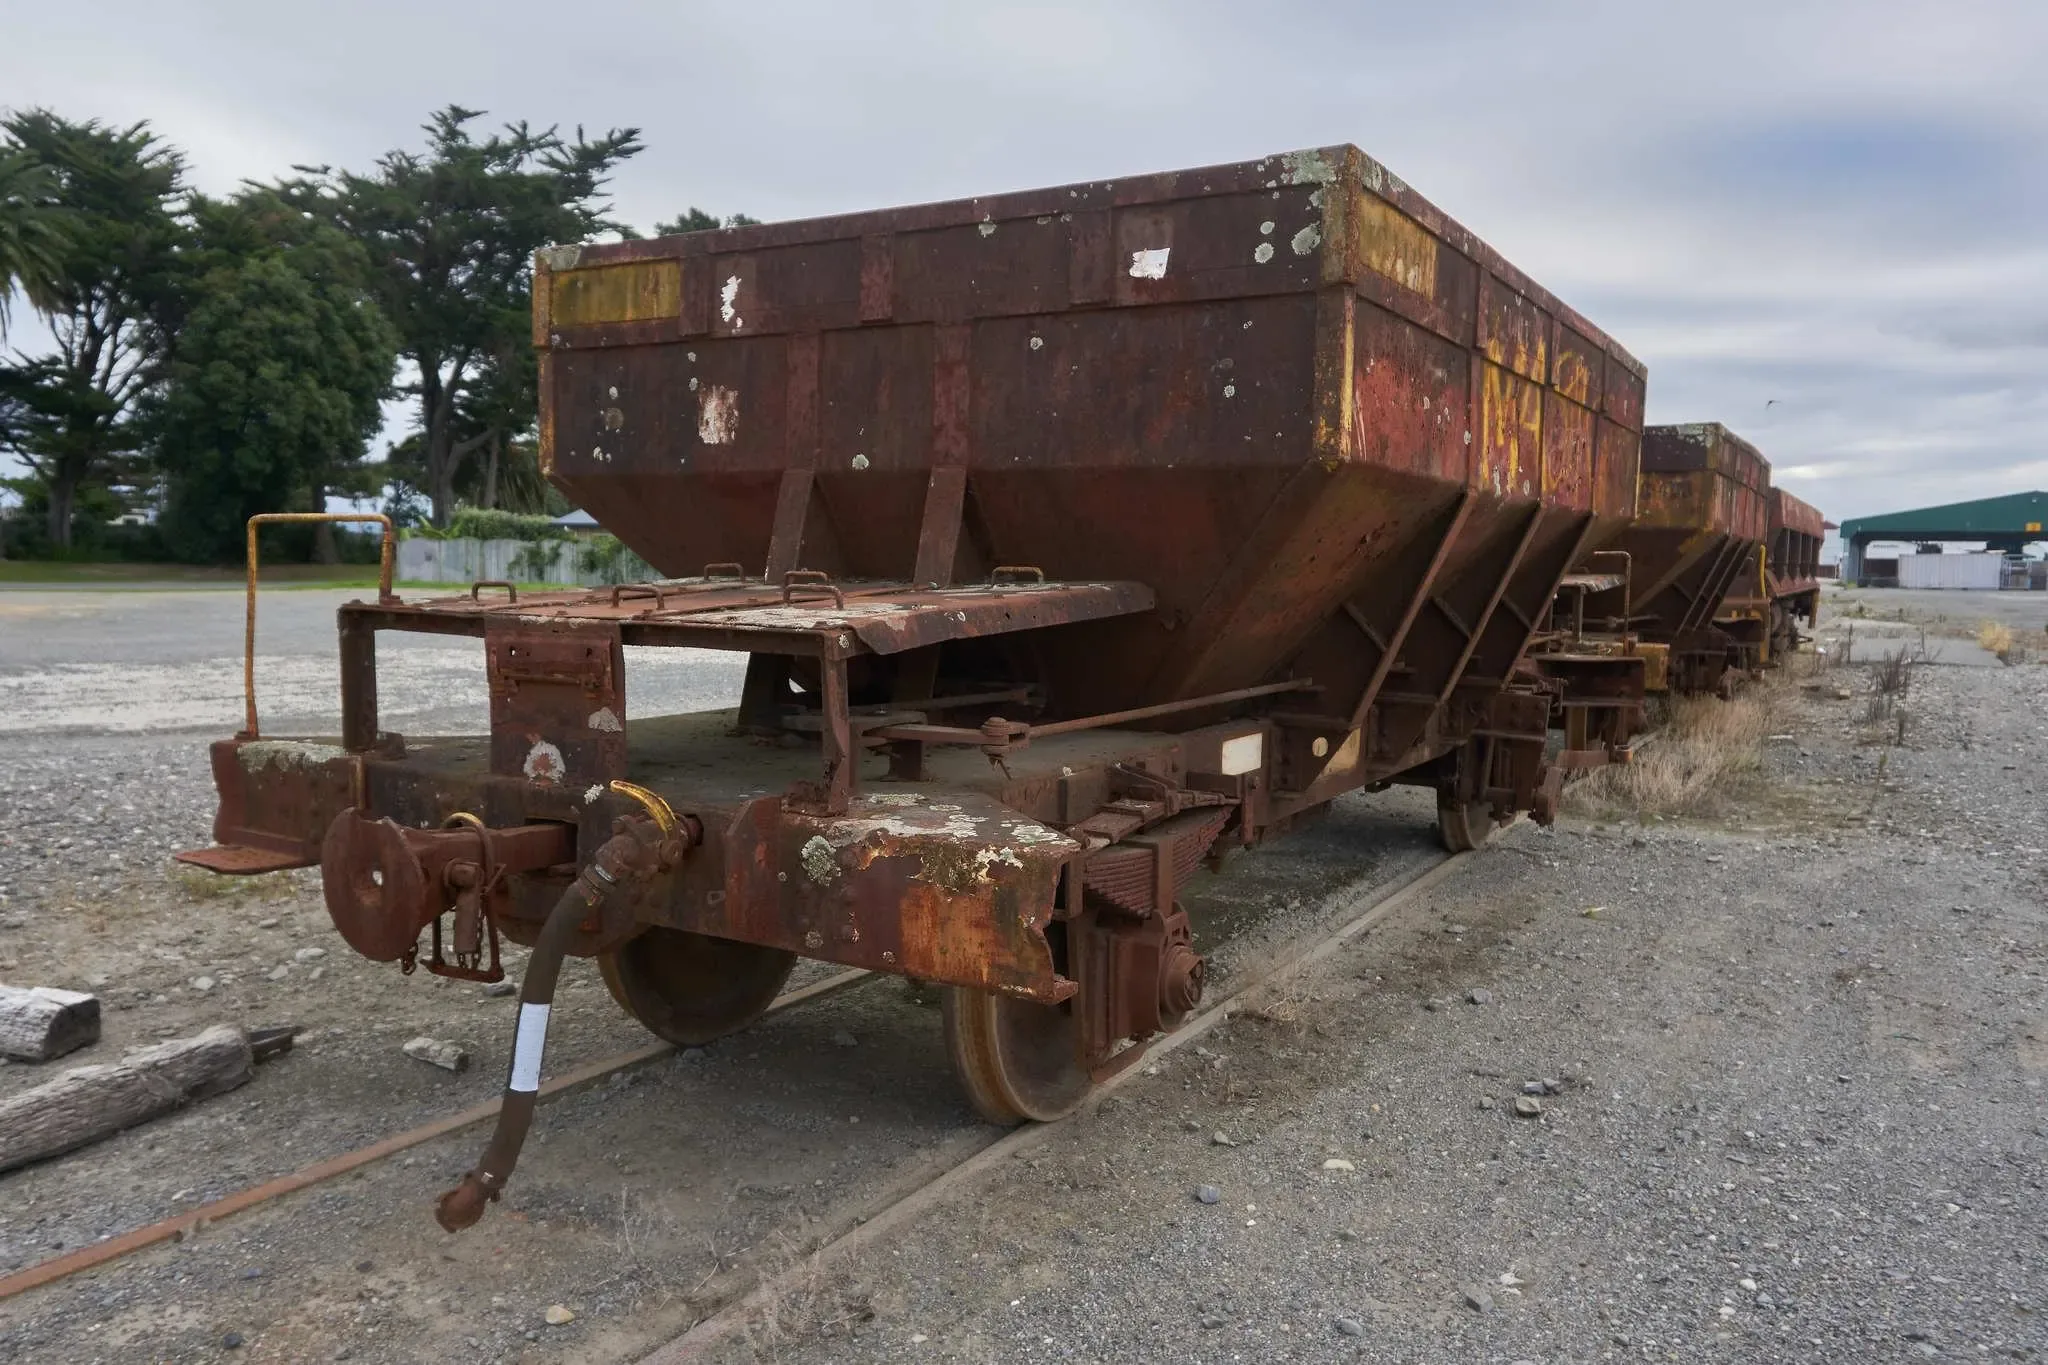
598, 927, 797, 1048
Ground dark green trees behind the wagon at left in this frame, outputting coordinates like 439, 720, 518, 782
0, 104, 752, 561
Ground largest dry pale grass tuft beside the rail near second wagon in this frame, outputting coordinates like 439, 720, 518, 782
1567, 684, 1782, 819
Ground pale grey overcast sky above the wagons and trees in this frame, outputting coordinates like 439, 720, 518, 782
0, 0, 2048, 520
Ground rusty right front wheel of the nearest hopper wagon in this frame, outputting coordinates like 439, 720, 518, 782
944, 986, 1094, 1128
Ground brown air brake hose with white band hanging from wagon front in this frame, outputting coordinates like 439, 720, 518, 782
434, 817, 659, 1232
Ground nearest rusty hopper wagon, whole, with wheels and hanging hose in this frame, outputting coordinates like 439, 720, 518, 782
188, 147, 1642, 1226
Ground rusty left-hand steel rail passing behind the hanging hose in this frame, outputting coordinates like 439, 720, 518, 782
0, 968, 874, 1302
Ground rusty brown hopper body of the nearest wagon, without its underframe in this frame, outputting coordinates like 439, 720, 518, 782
537, 147, 1642, 712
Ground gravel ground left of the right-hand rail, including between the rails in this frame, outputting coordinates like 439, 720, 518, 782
0, 591, 1434, 1361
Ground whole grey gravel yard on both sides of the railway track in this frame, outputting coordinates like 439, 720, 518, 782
0, 591, 2048, 1363
